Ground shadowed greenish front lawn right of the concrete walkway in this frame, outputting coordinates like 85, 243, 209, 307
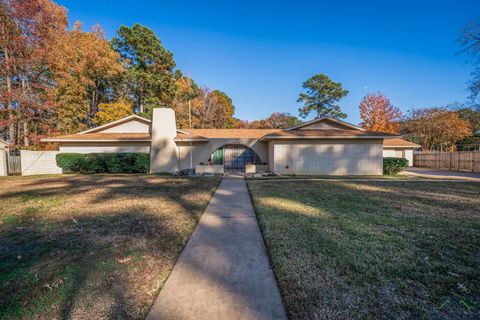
248, 180, 480, 319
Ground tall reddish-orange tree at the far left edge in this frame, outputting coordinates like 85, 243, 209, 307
0, 0, 68, 147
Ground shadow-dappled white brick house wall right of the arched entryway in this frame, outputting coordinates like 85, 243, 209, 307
274, 140, 383, 175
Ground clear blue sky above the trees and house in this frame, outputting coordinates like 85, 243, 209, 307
57, 0, 480, 123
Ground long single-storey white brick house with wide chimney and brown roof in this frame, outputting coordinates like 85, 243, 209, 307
44, 108, 399, 175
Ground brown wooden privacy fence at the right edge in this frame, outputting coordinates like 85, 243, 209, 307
413, 151, 480, 172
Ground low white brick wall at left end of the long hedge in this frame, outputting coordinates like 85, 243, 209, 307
20, 150, 62, 176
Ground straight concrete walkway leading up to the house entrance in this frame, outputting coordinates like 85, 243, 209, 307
147, 176, 286, 320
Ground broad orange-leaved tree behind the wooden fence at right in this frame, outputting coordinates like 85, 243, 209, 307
401, 108, 472, 151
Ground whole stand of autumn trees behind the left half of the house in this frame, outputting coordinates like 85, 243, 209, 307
0, 0, 240, 148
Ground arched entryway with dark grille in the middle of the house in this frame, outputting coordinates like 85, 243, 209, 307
209, 144, 262, 172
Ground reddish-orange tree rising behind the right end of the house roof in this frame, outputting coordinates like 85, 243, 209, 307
359, 92, 402, 133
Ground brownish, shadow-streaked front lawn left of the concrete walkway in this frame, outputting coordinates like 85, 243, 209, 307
0, 175, 220, 319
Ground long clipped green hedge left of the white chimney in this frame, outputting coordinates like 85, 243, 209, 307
56, 153, 150, 173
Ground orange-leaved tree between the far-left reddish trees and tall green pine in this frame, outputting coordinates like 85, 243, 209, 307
50, 21, 124, 133
